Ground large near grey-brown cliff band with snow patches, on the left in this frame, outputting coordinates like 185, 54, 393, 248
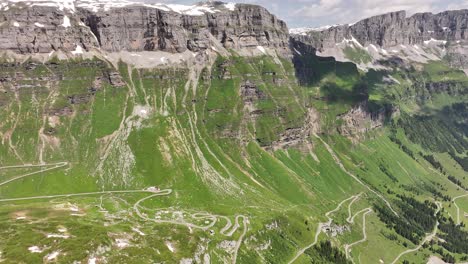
0, 1, 289, 55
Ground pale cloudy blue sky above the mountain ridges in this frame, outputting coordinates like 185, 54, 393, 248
143, 0, 468, 28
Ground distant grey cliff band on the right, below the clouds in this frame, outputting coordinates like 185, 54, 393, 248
294, 10, 468, 50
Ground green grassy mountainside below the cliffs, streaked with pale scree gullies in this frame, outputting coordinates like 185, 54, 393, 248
0, 50, 468, 263
